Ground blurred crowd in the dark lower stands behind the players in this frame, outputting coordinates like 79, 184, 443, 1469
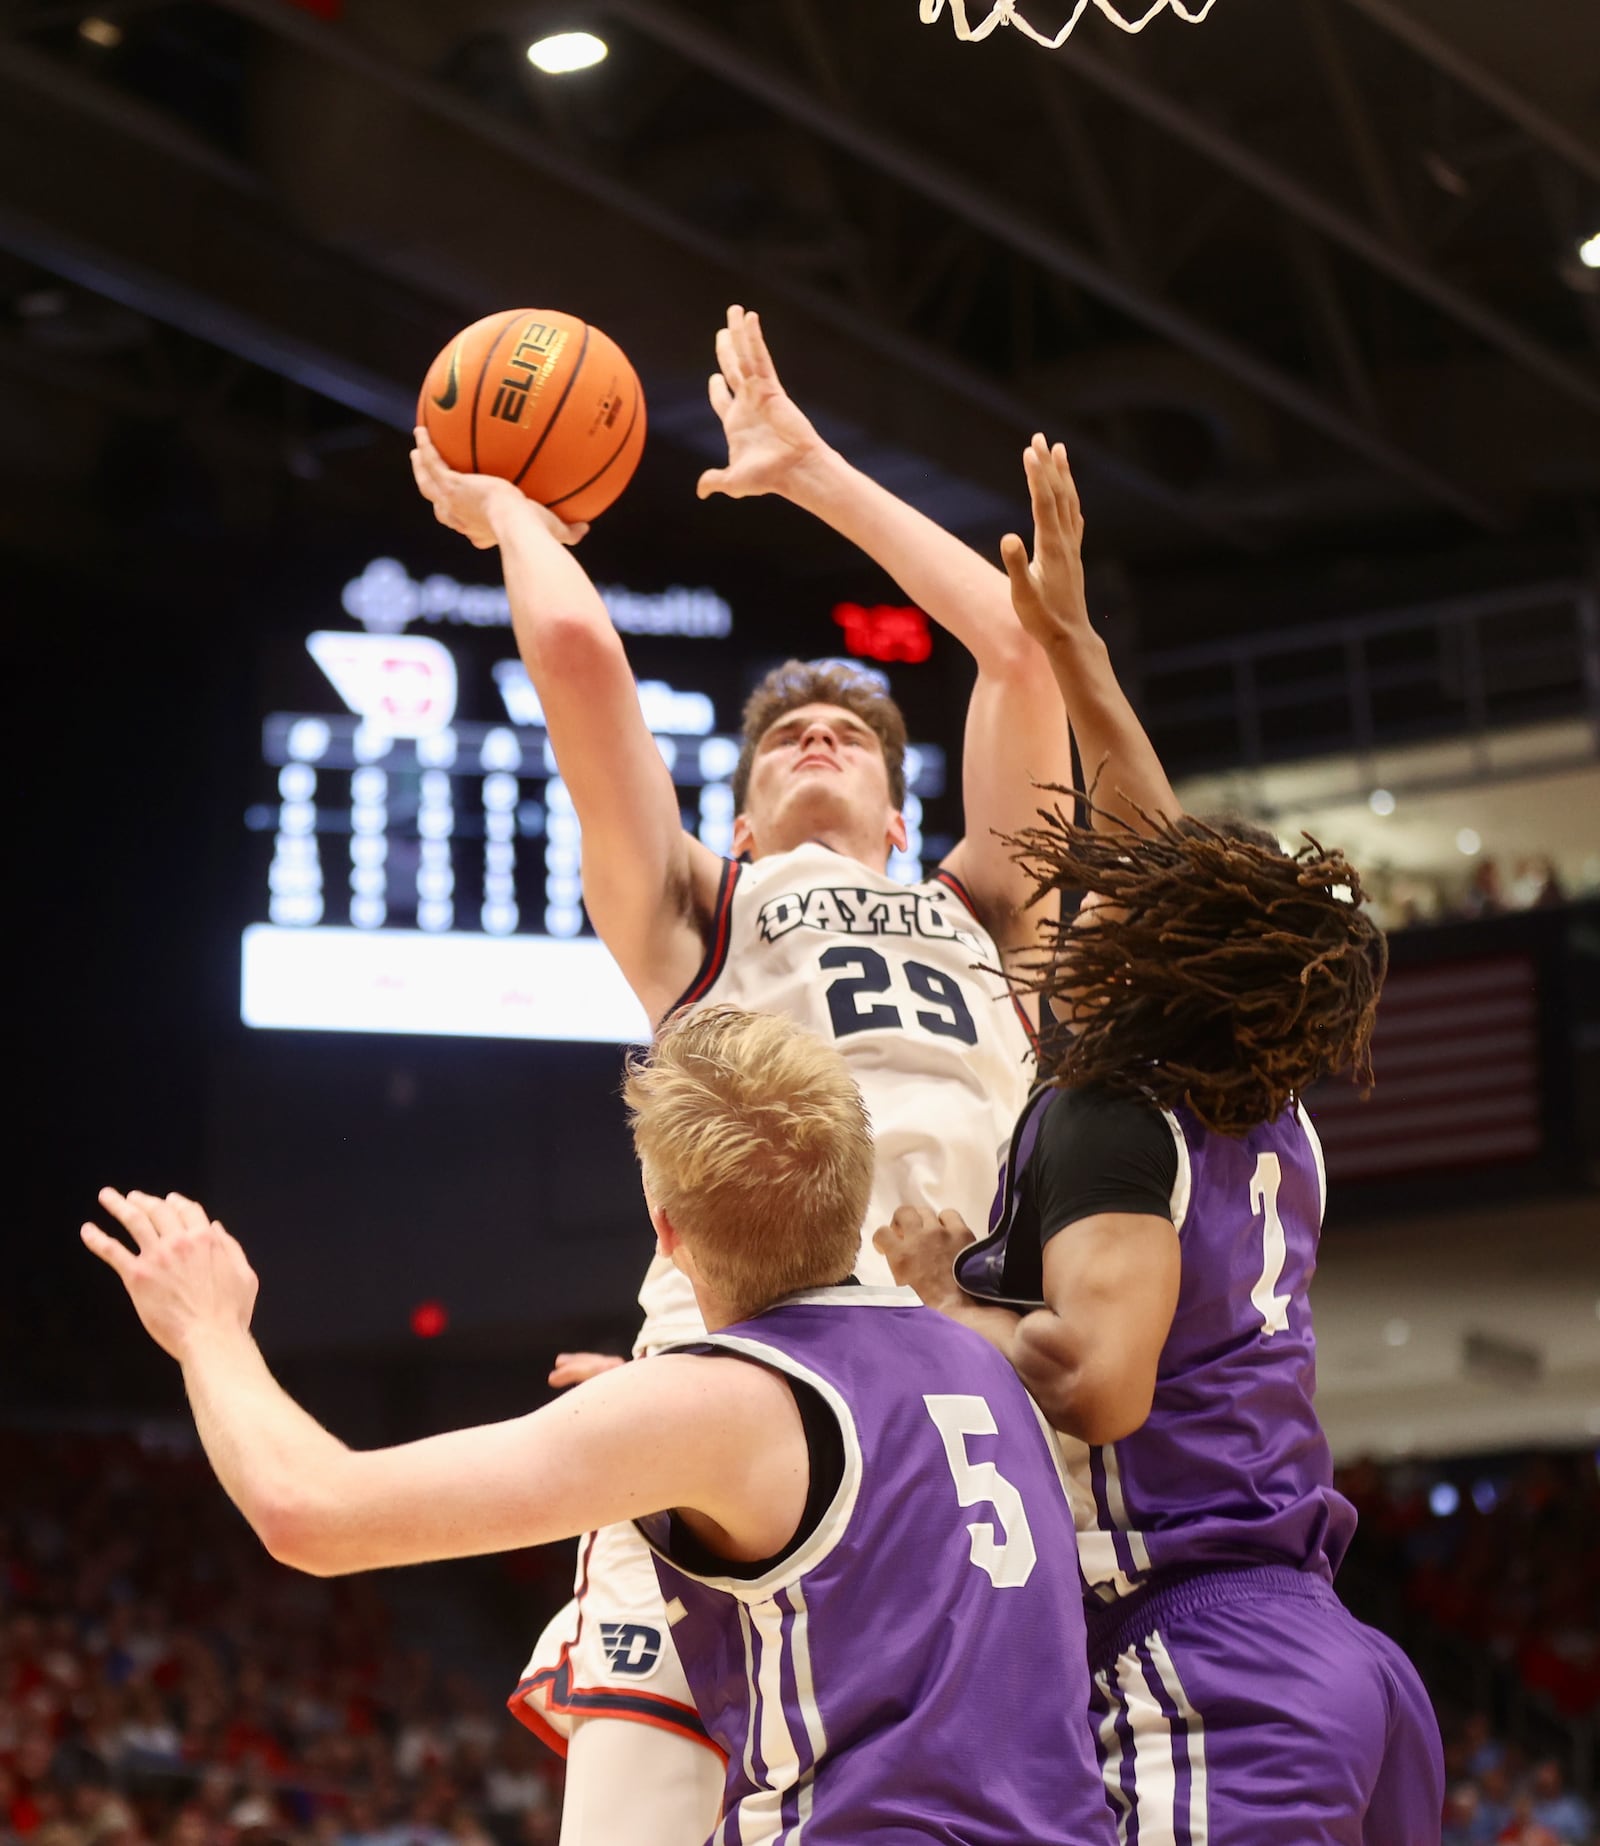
0, 1431, 1600, 1846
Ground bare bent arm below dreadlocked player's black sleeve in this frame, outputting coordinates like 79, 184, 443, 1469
1011, 1211, 1181, 1445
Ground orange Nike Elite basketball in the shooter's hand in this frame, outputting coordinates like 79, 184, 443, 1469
417, 308, 644, 522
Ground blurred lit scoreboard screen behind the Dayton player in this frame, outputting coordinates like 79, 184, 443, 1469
240, 559, 947, 1043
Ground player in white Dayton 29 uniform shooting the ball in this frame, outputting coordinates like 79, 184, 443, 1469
413, 306, 1166, 1846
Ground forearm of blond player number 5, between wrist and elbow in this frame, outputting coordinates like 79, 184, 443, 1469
183, 1329, 349, 1569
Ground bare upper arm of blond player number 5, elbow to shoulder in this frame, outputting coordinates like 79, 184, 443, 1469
262, 1353, 808, 1576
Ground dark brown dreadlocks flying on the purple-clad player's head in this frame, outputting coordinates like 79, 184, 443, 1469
1006, 788, 1388, 1135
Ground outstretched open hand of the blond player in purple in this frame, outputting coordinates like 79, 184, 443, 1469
79, 1185, 257, 1364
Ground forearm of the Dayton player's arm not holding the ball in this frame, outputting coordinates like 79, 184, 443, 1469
784, 449, 1037, 674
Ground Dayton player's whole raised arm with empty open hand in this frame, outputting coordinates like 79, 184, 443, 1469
699, 306, 1072, 951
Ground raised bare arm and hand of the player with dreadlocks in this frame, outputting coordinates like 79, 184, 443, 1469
1000, 436, 1181, 831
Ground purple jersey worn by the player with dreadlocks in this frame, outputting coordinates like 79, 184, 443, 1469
958, 1098, 1356, 1602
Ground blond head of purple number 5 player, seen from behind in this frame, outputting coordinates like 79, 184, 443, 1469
622, 1006, 873, 1320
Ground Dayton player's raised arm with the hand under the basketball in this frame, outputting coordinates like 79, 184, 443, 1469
412, 430, 720, 1019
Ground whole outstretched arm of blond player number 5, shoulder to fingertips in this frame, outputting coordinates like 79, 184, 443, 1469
83, 1189, 806, 1576
